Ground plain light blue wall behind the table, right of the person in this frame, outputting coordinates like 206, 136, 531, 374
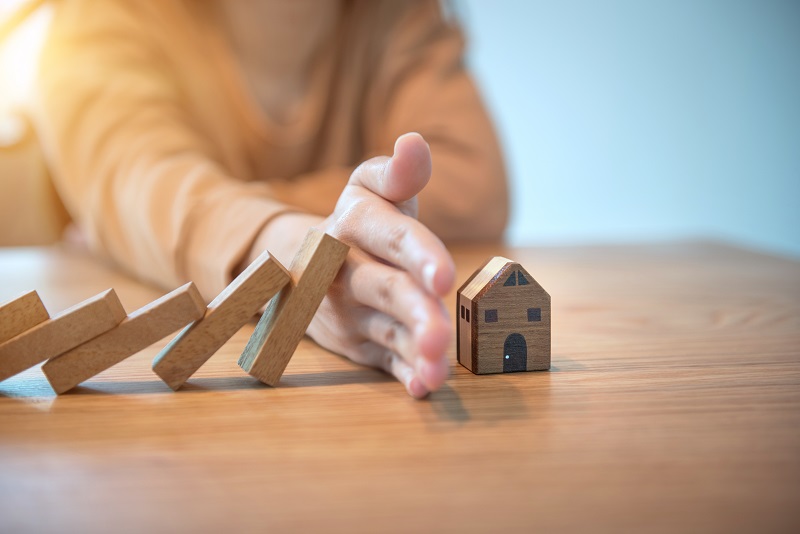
453, 0, 800, 257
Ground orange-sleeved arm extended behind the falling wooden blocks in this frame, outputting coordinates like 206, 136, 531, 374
36, 1, 291, 299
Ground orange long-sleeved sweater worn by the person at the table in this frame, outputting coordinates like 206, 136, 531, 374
35, 0, 507, 298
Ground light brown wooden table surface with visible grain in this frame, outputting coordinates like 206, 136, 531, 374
0, 242, 800, 532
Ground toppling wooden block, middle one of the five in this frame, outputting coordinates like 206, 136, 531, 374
42, 282, 206, 394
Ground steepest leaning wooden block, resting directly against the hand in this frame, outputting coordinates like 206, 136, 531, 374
239, 229, 350, 386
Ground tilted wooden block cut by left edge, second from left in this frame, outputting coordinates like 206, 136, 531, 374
0, 289, 125, 381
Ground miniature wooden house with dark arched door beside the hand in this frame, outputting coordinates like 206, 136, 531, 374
456, 256, 550, 375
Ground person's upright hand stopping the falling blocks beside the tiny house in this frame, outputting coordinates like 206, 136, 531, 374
247, 133, 455, 398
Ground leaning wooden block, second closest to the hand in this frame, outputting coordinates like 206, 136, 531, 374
153, 252, 290, 390
